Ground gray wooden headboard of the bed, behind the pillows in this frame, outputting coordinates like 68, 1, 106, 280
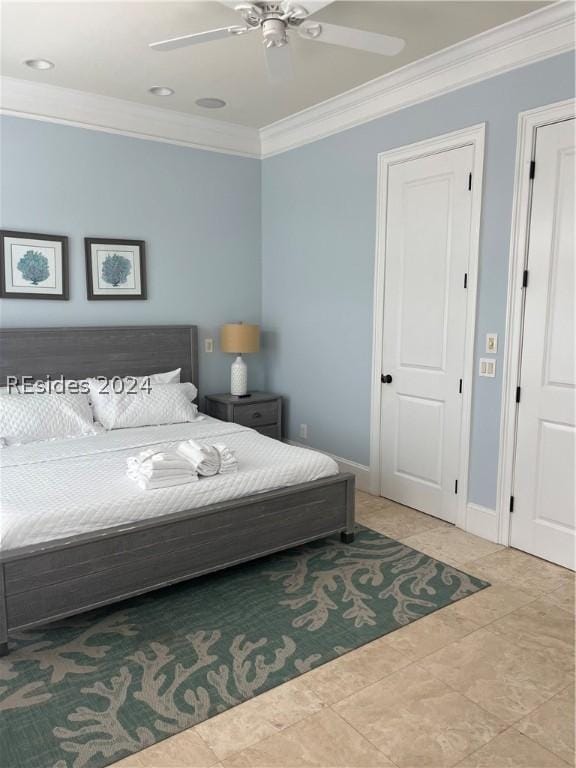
0, 325, 198, 386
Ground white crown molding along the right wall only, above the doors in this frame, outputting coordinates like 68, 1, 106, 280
260, 0, 575, 158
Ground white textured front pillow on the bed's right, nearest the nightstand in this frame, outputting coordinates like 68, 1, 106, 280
90, 379, 198, 429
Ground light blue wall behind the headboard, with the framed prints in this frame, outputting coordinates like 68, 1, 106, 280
0, 117, 262, 400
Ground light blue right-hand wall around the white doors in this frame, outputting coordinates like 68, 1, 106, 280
262, 54, 574, 507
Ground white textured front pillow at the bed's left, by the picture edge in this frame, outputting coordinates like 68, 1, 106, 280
0, 394, 102, 445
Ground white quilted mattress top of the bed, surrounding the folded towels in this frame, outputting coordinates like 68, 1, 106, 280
0, 417, 338, 551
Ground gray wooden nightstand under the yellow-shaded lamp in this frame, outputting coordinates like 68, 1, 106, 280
205, 392, 282, 440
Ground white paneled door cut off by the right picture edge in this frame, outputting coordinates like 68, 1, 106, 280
510, 120, 576, 568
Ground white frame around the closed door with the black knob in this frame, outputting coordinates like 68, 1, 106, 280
370, 123, 485, 528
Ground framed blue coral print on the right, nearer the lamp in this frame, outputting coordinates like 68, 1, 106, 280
84, 237, 146, 301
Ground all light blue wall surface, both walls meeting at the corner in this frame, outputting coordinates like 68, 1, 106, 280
0, 54, 574, 507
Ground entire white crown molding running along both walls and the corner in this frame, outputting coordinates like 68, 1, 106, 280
0, 0, 576, 158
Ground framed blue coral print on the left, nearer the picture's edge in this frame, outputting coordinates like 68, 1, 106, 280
0, 229, 68, 300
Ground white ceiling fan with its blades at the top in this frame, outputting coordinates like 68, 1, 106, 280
150, 0, 406, 82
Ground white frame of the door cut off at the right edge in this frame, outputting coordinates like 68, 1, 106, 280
496, 99, 576, 546
